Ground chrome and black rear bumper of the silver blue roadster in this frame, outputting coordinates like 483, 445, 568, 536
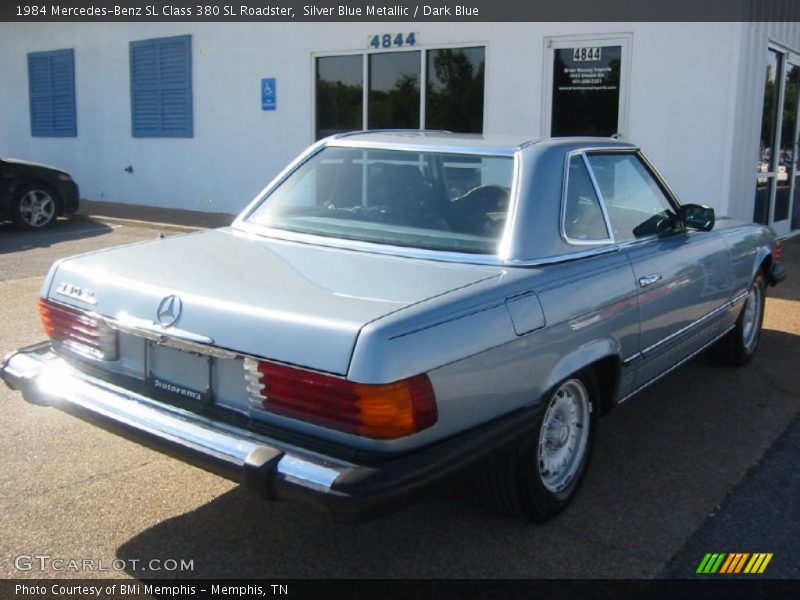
0, 343, 532, 520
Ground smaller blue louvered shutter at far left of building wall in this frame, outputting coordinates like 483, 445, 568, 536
28, 49, 78, 137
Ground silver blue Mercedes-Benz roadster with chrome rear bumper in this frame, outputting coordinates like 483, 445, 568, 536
0, 131, 785, 520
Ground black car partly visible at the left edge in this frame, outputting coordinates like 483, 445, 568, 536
0, 158, 78, 229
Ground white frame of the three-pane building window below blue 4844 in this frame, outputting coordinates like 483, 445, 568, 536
310, 41, 489, 142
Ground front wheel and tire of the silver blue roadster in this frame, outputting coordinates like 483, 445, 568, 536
710, 272, 766, 367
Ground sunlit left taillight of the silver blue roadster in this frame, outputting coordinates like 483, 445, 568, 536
39, 298, 117, 360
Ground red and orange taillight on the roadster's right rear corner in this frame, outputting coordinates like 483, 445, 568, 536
244, 358, 438, 439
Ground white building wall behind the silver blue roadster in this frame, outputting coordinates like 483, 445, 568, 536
0, 23, 763, 218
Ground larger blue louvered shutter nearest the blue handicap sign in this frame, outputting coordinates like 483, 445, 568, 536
130, 35, 193, 137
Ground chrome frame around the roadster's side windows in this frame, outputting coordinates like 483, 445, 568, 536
560, 146, 686, 248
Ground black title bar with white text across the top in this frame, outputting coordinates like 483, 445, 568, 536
0, 0, 800, 22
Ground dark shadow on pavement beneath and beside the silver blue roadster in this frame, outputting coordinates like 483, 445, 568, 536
117, 330, 800, 578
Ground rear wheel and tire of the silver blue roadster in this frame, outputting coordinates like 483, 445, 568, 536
481, 371, 599, 522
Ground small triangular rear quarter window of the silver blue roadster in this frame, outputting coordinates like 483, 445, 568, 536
564, 156, 610, 242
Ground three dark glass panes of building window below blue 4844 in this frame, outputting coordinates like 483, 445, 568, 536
315, 46, 485, 139
